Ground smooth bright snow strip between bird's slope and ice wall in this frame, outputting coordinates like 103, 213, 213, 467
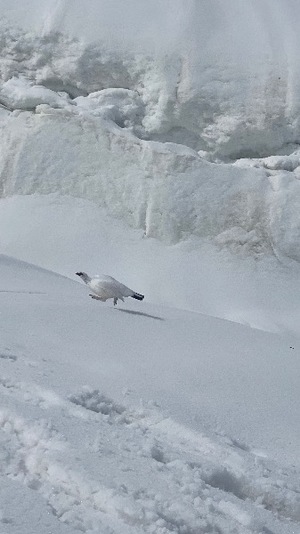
0, 194, 300, 335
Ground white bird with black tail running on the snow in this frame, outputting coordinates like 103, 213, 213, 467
75, 272, 144, 306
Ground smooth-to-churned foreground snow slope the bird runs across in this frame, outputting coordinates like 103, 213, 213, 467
0, 256, 300, 534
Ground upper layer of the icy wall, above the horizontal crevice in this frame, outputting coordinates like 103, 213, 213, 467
0, 0, 300, 158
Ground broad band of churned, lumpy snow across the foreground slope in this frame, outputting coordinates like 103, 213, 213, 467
0, 378, 300, 534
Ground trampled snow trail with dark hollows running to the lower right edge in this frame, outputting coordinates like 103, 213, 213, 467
69, 388, 300, 532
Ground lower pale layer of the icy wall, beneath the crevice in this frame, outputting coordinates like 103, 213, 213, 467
0, 103, 300, 259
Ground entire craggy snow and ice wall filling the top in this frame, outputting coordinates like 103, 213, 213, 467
0, 0, 300, 260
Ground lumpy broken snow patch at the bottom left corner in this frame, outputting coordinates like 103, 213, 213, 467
0, 411, 124, 532
